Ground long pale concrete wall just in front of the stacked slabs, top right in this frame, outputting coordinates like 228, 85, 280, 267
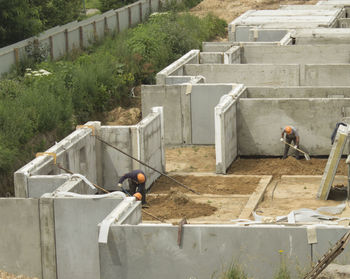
242, 45, 350, 64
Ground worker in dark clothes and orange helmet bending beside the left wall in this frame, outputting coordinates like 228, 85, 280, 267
118, 170, 146, 207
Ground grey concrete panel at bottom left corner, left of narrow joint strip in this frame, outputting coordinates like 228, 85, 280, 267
0, 198, 42, 278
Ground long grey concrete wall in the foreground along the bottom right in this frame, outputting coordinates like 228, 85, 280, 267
100, 224, 350, 279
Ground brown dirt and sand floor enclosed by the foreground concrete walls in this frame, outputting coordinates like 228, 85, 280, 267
143, 146, 350, 223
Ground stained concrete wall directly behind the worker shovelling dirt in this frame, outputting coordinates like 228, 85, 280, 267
237, 98, 350, 156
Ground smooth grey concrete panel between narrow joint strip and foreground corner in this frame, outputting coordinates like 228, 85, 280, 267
54, 198, 122, 279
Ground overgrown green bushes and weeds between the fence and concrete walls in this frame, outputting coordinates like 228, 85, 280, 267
0, 1, 226, 196
